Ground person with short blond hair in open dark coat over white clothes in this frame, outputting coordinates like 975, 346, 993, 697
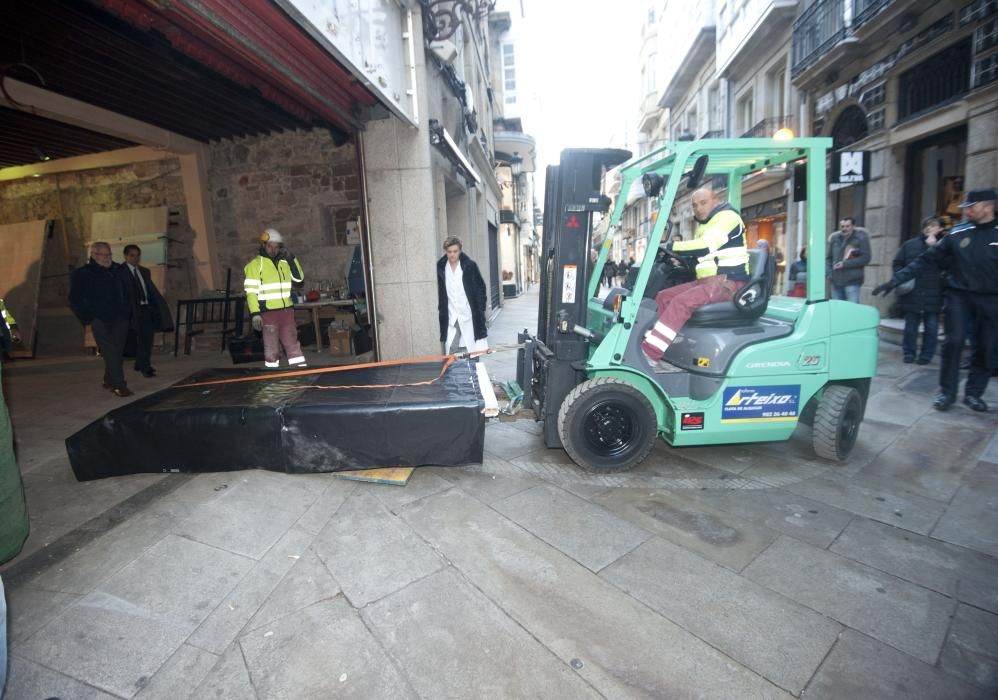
437, 236, 489, 353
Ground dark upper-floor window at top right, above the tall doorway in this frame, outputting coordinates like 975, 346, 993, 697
898, 37, 971, 121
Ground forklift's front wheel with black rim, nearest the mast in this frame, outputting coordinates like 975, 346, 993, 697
558, 377, 658, 472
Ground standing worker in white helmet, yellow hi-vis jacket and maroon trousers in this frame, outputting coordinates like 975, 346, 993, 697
243, 228, 305, 368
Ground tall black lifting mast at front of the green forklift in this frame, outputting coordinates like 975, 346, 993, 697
517, 149, 631, 447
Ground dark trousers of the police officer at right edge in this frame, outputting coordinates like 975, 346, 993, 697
939, 289, 998, 398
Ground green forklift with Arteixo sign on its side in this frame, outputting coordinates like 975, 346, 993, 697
517, 138, 879, 472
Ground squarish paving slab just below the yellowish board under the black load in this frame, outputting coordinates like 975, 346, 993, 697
315, 489, 444, 608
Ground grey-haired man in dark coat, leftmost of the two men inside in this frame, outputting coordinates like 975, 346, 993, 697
69, 242, 132, 396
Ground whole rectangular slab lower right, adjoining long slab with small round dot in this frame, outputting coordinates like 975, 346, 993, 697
601, 538, 842, 695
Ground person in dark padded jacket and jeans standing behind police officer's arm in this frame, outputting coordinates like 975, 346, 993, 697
892, 216, 943, 365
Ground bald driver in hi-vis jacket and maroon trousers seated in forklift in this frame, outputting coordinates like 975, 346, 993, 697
641, 187, 749, 365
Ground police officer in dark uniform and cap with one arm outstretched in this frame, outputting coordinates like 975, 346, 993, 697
873, 189, 998, 412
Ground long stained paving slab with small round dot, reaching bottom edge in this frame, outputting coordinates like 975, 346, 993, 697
402, 490, 790, 698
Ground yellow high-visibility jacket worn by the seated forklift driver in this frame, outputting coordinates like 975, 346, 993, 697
672, 203, 749, 281
